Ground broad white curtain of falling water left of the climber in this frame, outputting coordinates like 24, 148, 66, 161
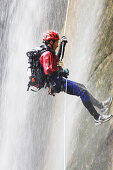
0, 0, 66, 170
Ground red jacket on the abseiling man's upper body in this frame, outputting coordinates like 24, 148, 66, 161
40, 51, 59, 75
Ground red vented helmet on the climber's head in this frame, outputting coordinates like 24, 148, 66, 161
43, 31, 60, 41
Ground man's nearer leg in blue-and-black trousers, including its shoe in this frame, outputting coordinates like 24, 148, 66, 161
54, 78, 112, 125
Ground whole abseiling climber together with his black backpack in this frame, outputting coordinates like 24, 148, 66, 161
27, 31, 112, 125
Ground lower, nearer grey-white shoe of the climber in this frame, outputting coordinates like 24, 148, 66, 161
95, 115, 113, 126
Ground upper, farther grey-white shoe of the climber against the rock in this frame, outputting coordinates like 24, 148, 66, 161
101, 97, 112, 113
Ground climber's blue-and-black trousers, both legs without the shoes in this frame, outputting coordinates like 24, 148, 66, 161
54, 77, 102, 119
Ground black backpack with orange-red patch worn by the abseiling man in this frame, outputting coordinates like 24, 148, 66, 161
26, 45, 47, 91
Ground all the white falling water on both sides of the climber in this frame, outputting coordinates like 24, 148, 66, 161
0, 0, 102, 170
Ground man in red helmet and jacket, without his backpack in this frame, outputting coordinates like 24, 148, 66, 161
40, 31, 112, 125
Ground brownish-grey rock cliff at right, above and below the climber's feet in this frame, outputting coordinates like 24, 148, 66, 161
67, 0, 113, 170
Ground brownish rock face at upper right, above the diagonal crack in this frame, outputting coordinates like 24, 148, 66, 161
92, 0, 113, 76
